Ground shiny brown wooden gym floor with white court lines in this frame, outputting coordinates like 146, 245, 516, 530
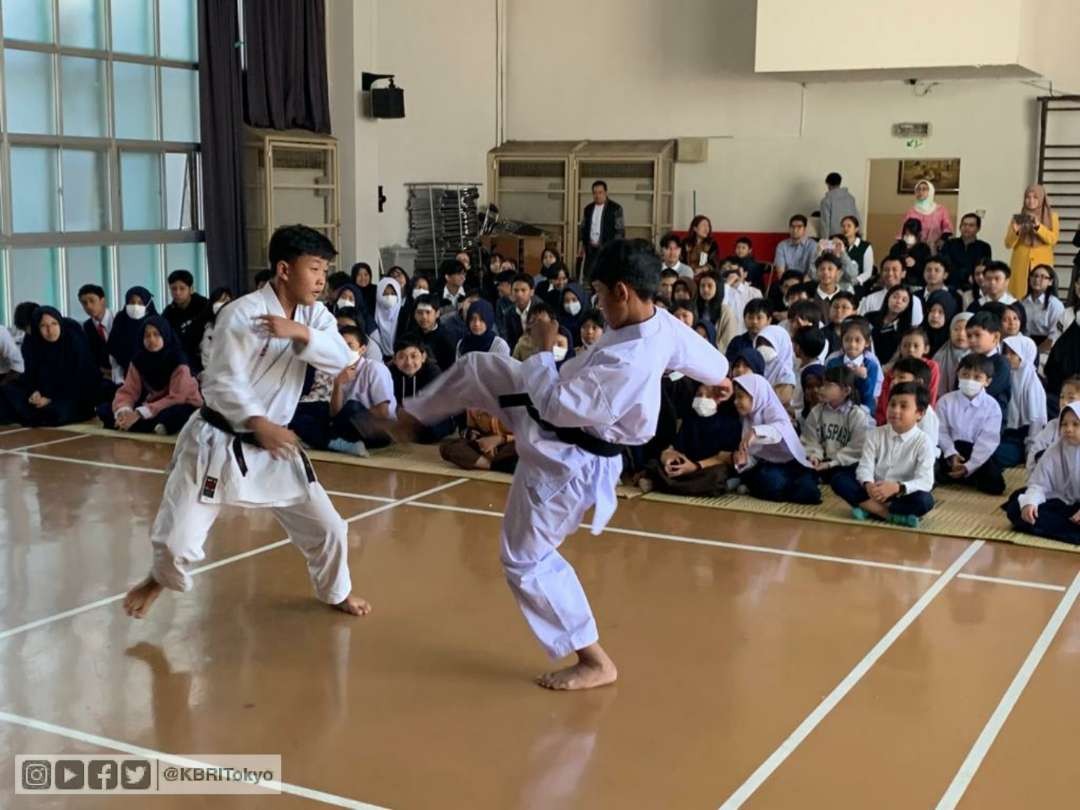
0, 429, 1080, 810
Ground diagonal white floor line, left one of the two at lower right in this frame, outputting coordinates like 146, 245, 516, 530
720, 540, 986, 810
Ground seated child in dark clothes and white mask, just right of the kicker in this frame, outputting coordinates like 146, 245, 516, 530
637, 386, 742, 496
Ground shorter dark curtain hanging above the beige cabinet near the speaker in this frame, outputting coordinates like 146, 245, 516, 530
244, 0, 330, 133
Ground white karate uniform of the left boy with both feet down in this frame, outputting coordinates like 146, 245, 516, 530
143, 284, 352, 605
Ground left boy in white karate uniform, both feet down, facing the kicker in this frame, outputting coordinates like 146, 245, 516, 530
124, 225, 370, 619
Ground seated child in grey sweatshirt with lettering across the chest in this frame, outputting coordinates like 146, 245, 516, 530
801, 366, 868, 481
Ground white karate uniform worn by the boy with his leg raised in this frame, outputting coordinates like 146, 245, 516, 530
403, 310, 728, 658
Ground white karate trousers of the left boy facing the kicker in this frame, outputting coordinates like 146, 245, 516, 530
150, 432, 352, 605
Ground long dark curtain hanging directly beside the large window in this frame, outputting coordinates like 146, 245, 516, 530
199, 0, 247, 295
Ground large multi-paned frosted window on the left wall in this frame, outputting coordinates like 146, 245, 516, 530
0, 0, 206, 323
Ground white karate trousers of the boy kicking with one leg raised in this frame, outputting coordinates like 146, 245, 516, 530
403, 352, 609, 659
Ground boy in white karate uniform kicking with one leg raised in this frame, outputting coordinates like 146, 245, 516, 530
395, 240, 731, 689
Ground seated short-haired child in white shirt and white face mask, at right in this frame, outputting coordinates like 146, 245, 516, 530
937, 354, 1005, 495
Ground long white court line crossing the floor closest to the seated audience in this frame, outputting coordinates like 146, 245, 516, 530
8, 451, 1065, 596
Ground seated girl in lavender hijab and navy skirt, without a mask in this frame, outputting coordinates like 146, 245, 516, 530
732, 374, 821, 503
